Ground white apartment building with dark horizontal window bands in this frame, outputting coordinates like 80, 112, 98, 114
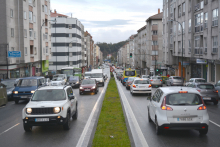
49, 10, 85, 71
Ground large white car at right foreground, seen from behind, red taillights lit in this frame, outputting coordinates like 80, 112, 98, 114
148, 87, 209, 135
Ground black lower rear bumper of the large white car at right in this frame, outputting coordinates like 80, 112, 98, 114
160, 123, 208, 130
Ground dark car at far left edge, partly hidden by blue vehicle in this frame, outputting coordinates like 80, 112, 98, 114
1, 79, 19, 100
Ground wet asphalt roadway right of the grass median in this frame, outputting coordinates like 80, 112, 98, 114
116, 79, 220, 147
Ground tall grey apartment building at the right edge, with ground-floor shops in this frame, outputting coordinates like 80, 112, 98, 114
163, 0, 220, 83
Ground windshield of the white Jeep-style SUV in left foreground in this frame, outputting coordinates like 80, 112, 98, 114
32, 89, 66, 101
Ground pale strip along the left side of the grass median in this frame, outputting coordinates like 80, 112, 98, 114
76, 70, 110, 147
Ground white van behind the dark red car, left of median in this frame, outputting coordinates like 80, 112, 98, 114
90, 69, 105, 86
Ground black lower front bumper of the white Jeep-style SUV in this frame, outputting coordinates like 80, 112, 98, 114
23, 116, 67, 126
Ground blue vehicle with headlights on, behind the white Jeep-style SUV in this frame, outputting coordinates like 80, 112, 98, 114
12, 77, 45, 104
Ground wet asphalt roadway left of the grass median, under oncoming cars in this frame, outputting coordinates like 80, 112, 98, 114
0, 69, 109, 147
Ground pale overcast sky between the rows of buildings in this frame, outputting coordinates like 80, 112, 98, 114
51, 0, 163, 43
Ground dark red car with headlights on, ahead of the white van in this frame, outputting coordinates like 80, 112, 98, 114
79, 79, 99, 95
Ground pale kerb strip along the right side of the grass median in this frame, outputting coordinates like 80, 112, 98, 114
115, 74, 149, 147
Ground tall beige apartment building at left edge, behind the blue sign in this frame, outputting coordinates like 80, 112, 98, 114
0, 0, 51, 78
